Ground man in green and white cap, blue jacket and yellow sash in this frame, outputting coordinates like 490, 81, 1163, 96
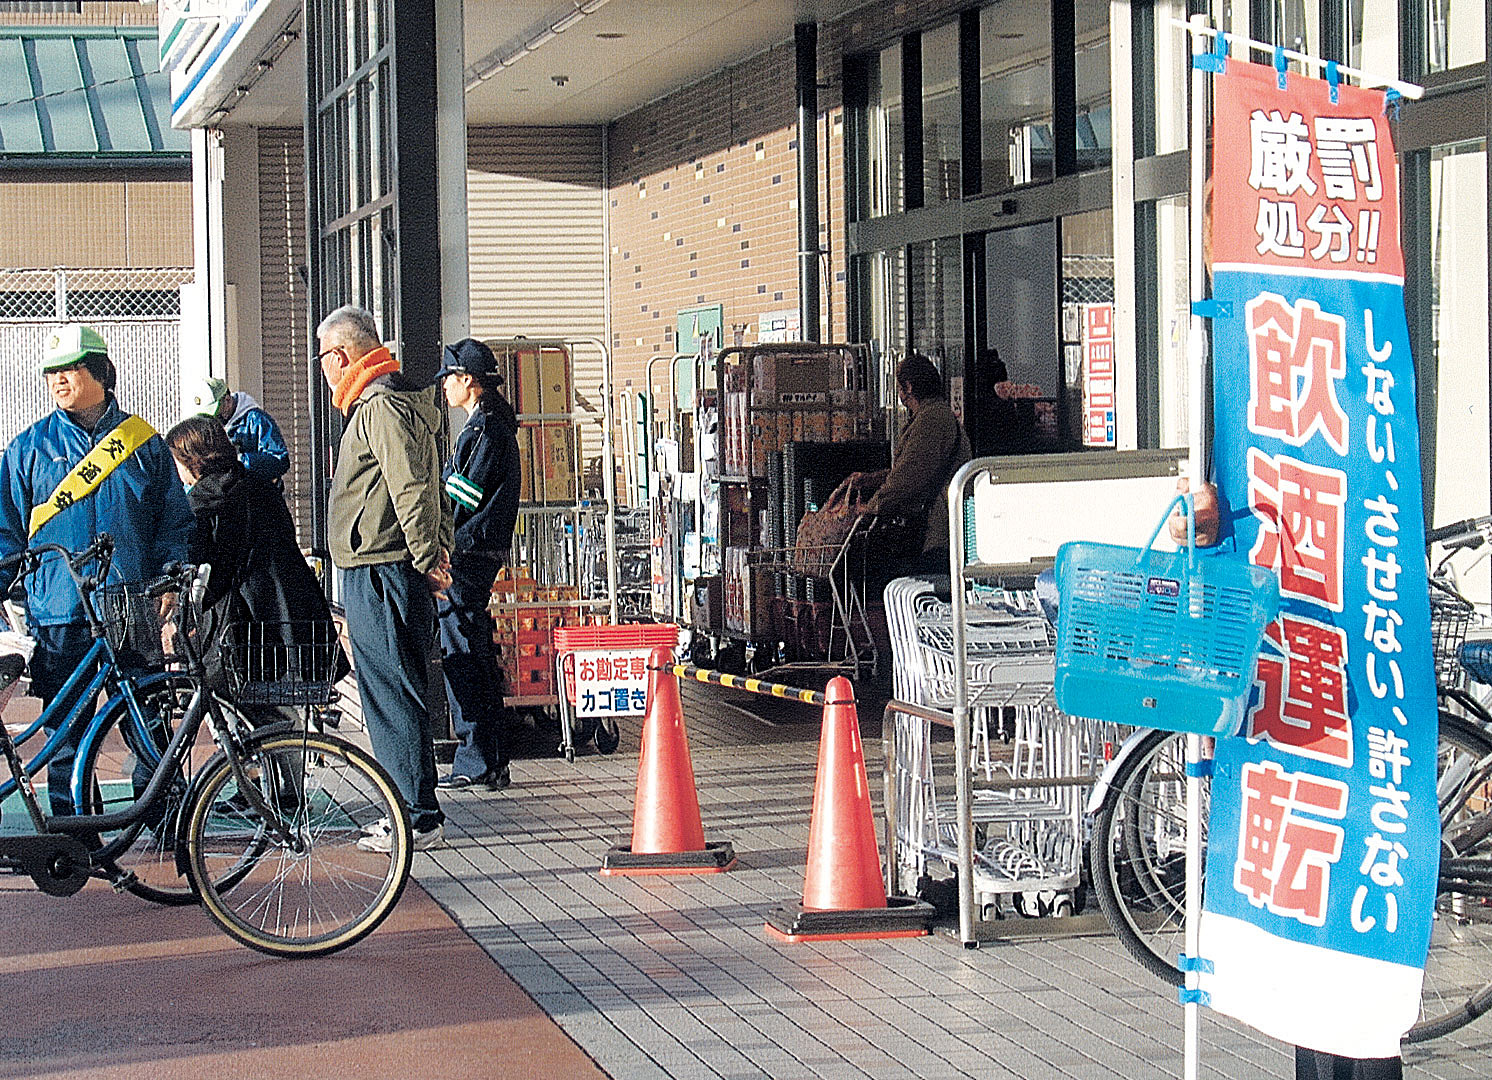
0, 324, 192, 813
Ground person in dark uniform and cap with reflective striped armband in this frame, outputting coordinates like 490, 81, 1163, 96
436, 337, 519, 791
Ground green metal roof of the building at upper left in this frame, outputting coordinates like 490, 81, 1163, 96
0, 27, 191, 167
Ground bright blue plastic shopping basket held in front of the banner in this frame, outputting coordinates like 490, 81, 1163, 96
1055, 495, 1280, 735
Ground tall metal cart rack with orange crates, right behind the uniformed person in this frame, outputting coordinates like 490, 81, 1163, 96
486, 337, 618, 715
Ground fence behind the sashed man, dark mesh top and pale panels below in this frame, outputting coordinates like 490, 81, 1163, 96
0, 267, 192, 445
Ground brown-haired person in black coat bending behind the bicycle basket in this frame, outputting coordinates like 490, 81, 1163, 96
166, 416, 349, 719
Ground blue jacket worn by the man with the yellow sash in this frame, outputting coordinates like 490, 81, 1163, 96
0, 394, 192, 627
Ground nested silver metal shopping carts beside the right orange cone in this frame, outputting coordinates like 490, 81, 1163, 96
886, 570, 1116, 919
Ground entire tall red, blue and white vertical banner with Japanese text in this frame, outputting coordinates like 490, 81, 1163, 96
1200, 61, 1440, 1058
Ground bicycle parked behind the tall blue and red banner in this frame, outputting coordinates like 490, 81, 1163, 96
1088, 518, 1492, 1043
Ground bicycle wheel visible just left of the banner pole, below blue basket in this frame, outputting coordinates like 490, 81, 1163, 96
1089, 731, 1210, 986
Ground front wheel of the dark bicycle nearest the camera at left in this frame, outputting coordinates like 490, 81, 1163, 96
182, 731, 413, 956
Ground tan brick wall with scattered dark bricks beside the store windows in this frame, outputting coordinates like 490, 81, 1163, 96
609, 43, 844, 396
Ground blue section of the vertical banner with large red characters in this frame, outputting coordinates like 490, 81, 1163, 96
1206, 267, 1440, 966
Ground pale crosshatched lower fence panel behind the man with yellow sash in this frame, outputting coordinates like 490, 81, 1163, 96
0, 318, 182, 446
